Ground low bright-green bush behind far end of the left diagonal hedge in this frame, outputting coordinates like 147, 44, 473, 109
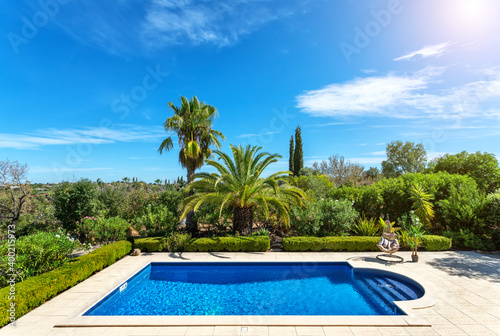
76, 217, 130, 243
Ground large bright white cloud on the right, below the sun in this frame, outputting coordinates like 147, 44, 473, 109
296, 67, 500, 121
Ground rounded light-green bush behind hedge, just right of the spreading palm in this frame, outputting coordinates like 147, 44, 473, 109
290, 199, 358, 236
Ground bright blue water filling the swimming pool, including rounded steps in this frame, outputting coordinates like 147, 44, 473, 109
84, 262, 423, 316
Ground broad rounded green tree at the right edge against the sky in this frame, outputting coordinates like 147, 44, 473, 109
429, 151, 500, 193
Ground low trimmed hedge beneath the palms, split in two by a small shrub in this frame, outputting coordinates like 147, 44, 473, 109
134, 236, 271, 252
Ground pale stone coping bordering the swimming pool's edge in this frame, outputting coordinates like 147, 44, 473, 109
54, 253, 439, 328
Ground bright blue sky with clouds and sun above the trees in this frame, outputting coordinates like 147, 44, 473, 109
0, 0, 500, 182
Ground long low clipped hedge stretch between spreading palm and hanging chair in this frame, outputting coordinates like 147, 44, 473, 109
283, 237, 380, 252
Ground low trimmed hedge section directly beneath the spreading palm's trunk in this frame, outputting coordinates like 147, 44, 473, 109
186, 236, 270, 252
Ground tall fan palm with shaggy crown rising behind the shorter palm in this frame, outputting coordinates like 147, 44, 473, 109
158, 96, 225, 233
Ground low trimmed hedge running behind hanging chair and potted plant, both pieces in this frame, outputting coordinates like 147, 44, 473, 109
283, 235, 451, 252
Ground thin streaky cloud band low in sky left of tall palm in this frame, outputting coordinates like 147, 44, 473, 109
0, 125, 164, 149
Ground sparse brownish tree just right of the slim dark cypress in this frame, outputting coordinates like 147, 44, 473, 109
313, 155, 365, 187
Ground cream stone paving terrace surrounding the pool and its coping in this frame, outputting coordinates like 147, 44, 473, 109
0, 252, 500, 336
